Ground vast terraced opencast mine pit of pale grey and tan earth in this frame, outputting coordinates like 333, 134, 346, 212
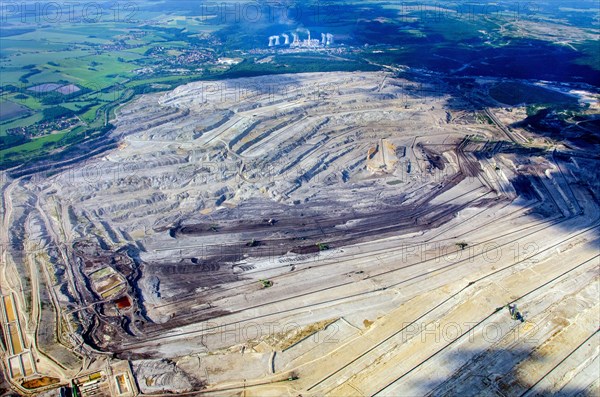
2, 72, 600, 396
